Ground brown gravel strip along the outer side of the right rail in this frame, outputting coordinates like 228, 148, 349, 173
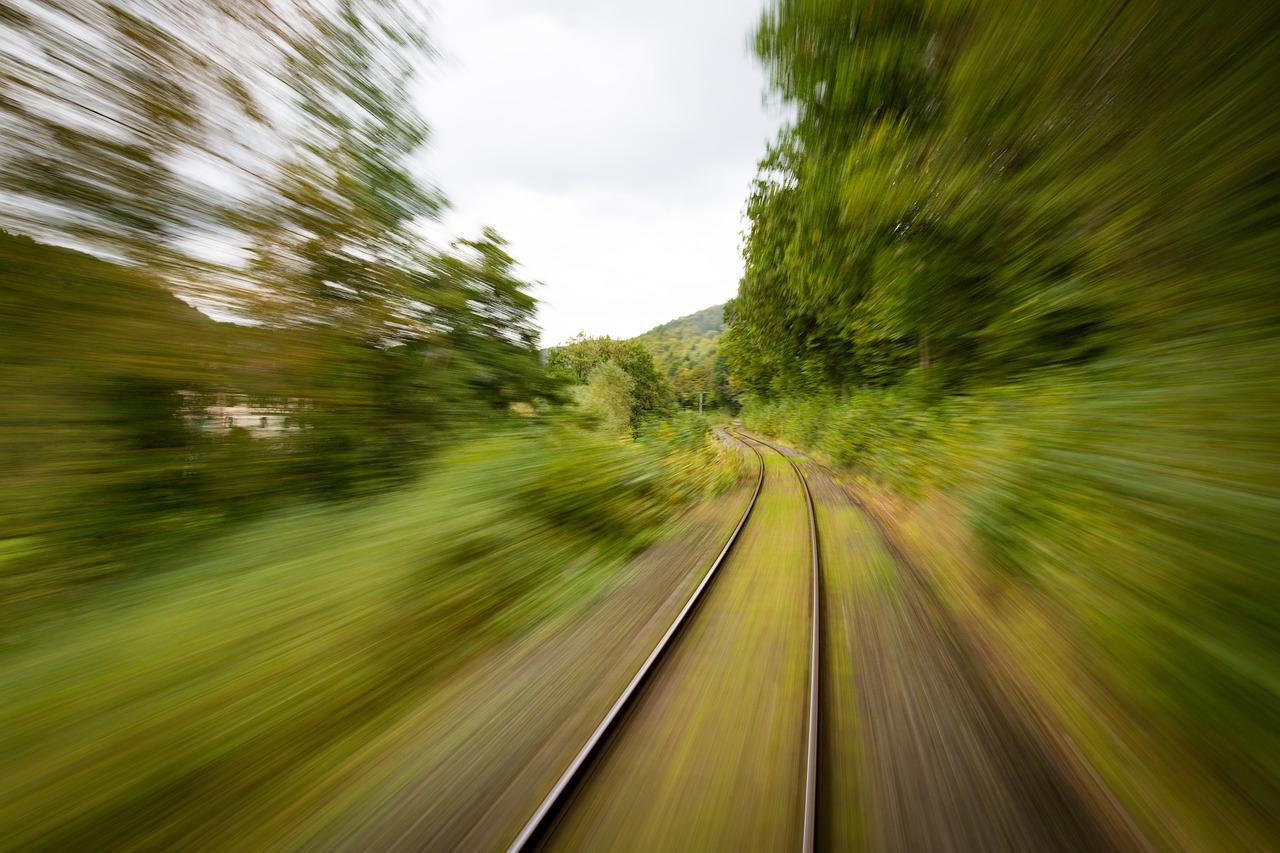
805, 448, 1135, 852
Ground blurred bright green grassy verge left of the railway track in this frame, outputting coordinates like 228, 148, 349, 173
0, 429, 733, 848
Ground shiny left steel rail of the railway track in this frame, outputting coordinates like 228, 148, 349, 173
507, 427, 764, 853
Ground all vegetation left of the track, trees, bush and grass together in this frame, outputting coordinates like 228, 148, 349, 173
0, 6, 739, 848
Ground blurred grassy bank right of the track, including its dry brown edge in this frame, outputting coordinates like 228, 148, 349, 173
744, 347, 1280, 849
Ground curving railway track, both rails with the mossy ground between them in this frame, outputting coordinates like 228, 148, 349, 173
508, 433, 822, 853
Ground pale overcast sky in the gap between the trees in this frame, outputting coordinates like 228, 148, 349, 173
421, 0, 781, 345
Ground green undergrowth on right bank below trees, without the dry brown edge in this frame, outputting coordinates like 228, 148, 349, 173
744, 345, 1280, 793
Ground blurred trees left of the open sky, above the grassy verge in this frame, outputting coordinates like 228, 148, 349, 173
0, 0, 552, 598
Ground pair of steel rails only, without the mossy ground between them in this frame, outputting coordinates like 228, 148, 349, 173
507, 432, 820, 853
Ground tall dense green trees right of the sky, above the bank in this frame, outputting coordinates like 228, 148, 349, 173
724, 0, 1280, 396
